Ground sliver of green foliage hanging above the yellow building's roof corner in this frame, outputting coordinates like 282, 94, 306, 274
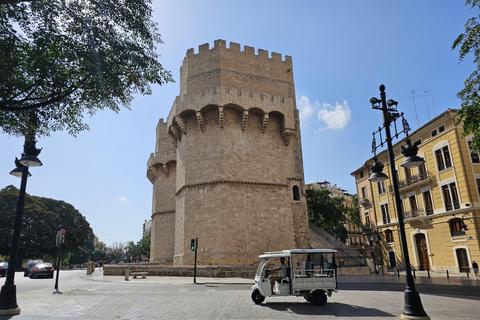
452, 0, 480, 152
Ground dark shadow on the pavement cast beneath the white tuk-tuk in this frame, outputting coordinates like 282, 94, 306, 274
261, 302, 398, 318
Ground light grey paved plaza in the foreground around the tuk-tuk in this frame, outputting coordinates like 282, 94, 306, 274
0, 270, 480, 320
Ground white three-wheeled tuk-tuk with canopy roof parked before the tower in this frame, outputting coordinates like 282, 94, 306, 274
252, 249, 337, 306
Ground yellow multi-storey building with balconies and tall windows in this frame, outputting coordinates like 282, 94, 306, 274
352, 109, 480, 273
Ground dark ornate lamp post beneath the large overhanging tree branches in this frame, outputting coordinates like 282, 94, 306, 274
0, 138, 42, 316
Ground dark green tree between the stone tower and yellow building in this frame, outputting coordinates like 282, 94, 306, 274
307, 189, 348, 242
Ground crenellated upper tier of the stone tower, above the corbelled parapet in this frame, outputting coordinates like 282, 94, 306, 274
180, 40, 295, 98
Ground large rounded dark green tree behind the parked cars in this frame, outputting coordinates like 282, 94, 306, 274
0, 186, 91, 263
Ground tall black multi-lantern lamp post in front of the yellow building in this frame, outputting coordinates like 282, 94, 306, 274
369, 84, 430, 319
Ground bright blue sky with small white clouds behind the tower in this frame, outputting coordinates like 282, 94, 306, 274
0, 0, 479, 246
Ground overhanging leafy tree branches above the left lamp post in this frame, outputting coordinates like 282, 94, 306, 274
0, 0, 173, 136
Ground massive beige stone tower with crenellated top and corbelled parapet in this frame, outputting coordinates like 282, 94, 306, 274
147, 40, 309, 266
